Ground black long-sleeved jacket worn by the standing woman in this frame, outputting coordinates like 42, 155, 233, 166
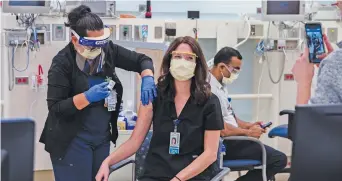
39, 41, 153, 158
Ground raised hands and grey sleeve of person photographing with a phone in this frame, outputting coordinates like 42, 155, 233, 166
292, 35, 342, 104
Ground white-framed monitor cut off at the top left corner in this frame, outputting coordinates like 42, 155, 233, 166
2, 0, 51, 14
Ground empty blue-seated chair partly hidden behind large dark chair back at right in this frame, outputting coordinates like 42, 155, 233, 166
268, 110, 295, 179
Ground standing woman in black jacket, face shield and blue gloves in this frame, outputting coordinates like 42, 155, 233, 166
40, 6, 156, 181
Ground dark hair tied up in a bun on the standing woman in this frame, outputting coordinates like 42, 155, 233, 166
65, 5, 103, 37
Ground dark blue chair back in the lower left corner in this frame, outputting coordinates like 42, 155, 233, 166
1, 119, 35, 181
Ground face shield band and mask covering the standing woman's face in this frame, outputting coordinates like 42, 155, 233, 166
71, 28, 110, 59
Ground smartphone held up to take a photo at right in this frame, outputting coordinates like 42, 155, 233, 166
305, 22, 325, 64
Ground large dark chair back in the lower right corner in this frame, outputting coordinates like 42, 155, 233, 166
291, 105, 342, 181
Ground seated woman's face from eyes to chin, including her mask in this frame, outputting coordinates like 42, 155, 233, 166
170, 52, 196, 81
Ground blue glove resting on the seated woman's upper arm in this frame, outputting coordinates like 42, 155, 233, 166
140, 76, 157, 106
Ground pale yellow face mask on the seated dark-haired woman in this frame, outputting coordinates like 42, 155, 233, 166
170, 58, 196, 81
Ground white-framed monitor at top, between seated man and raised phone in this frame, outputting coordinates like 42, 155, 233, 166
262, 0, 305, 21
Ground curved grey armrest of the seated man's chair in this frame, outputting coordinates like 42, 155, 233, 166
223, 136, 267, 181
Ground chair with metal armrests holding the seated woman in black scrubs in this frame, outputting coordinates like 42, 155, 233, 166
110, 131, 230, 181
